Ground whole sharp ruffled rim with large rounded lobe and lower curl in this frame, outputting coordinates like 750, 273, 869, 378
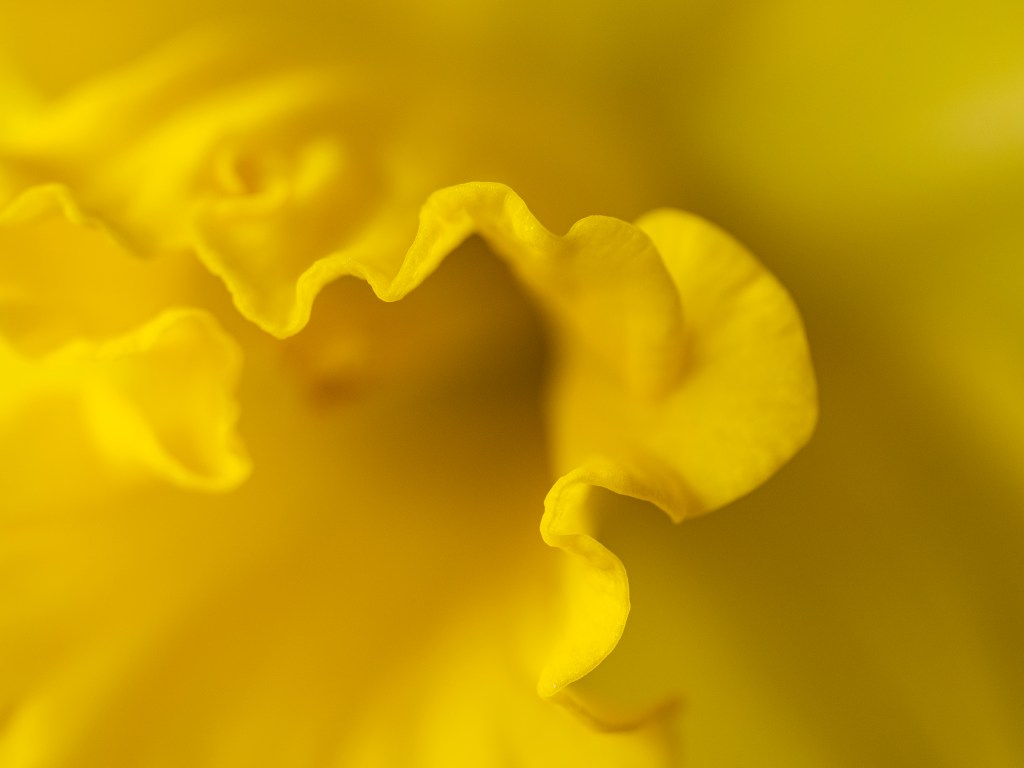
0, 177, 817, 710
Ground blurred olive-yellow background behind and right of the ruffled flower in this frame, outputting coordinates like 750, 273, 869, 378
0, 0, 1024, 767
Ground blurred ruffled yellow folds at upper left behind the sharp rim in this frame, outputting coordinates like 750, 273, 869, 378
0, 28, 441, 337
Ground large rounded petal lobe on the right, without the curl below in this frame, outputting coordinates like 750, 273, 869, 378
552, 210, 817, 521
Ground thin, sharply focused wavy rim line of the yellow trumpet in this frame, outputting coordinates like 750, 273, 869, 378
0, 176, 806, 730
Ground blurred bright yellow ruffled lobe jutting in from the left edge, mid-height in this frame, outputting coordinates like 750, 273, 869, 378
0, 309, 250, 505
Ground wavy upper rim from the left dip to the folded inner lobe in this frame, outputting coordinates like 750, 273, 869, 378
201, 182, 682, 391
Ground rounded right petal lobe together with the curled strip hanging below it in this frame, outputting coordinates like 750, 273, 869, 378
538, 210, 817, 712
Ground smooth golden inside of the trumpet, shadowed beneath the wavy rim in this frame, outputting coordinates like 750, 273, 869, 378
0, 237, 593, 767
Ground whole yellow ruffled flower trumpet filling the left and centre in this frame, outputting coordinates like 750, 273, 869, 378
0, 5, 816, 766
